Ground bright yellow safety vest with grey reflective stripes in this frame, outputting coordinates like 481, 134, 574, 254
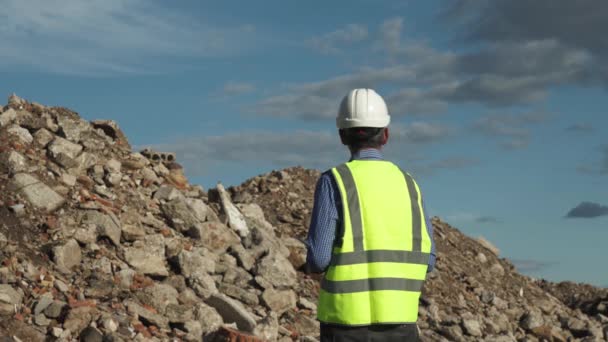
317, 160, 431, 326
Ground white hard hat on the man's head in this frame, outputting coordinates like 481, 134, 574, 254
336, 89, 391, 129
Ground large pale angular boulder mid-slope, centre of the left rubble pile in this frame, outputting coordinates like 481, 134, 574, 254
125, 234, 169, 277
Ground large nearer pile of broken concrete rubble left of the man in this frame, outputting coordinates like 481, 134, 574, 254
0, 95, 318, 341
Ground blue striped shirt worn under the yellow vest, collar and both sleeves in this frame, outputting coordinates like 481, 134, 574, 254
306, 149, 436, 273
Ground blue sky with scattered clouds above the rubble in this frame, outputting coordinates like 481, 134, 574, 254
0, 0, 608, 286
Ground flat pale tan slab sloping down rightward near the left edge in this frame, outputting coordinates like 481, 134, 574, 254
9, 173, 65, 213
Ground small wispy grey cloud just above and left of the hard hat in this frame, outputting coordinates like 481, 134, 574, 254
306, 24, 368, 53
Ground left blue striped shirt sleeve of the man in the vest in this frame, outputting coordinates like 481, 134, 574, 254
306, 172, 339, 273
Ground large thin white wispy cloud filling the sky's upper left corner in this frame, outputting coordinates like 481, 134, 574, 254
0, 0, 255, 75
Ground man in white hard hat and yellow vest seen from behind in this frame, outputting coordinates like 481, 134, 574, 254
306, 89, 435, 342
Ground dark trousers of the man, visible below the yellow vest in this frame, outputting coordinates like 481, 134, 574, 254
321, 323, 420, 342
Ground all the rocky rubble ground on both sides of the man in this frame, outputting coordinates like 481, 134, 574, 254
0, 96, 608, 341
